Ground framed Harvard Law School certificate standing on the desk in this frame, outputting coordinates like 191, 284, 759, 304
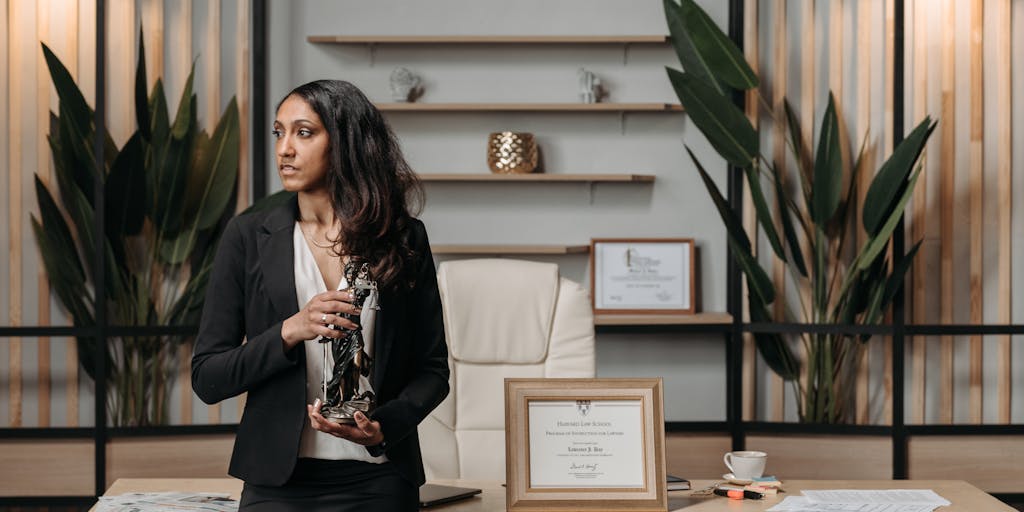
505, 379, 668, 511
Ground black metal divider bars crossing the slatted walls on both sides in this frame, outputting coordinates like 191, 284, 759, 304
0, 0, 1024, 507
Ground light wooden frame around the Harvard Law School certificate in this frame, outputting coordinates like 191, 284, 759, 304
505, 378, 669, 512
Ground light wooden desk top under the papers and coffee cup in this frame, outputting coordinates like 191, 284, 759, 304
97, 478, 1016, 512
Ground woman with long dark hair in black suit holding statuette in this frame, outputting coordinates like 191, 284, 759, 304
193, 80, 449, 511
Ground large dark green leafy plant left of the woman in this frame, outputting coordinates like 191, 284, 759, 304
32, 34, 240, 426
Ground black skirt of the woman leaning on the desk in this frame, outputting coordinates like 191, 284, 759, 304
239, 459, 419, 512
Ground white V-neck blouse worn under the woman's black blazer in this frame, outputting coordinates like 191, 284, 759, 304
292, 222, 387, 464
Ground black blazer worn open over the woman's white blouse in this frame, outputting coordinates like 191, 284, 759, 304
191, 199, 449, 485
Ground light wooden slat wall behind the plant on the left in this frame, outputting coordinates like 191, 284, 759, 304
0, 0, 251, 427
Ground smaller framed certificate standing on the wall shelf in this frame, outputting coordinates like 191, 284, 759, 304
590, 239, 695, 314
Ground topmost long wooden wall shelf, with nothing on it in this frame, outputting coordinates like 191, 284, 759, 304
306, 35, 669, 44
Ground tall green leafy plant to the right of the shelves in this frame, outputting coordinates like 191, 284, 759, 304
664, 0, 936, 423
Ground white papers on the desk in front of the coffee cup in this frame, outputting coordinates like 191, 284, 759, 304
768, 488, 949, 512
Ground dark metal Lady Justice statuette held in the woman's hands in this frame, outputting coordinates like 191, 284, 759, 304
319, 261, 380, 425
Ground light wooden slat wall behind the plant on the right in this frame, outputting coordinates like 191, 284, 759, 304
744, 0, 1021, 423
